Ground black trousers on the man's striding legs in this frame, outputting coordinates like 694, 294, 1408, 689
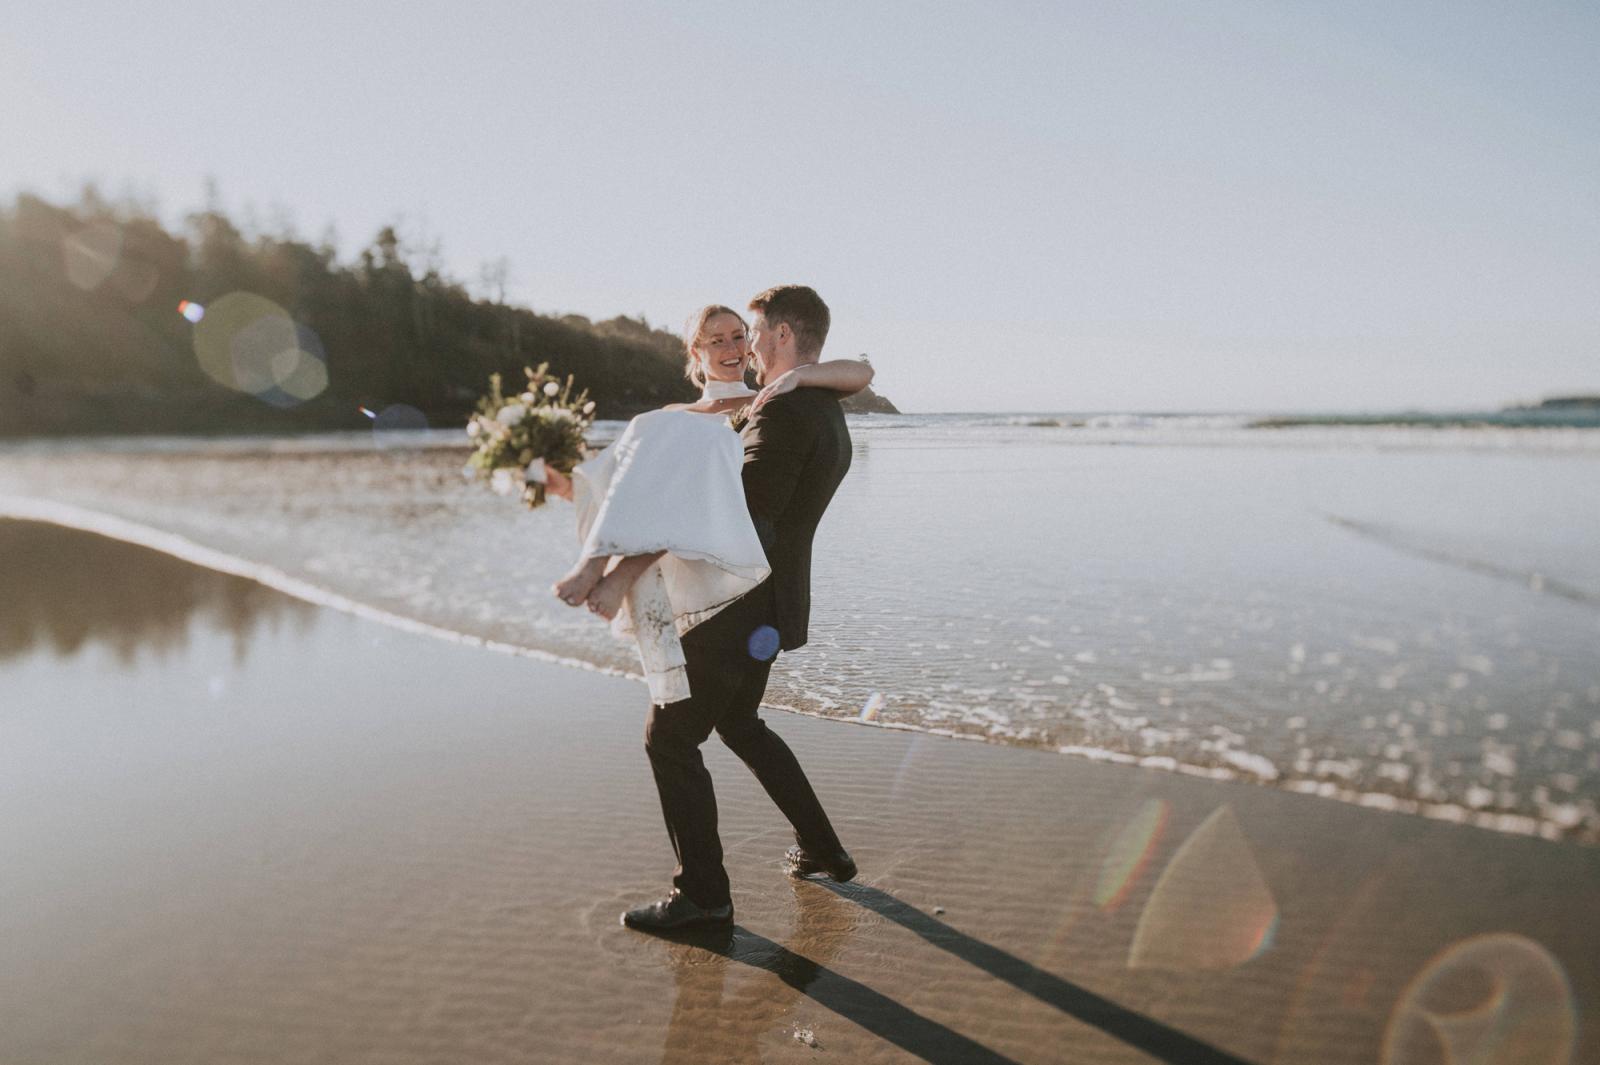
645, 596, 840, 907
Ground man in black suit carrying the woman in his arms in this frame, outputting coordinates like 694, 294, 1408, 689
622, 285, 856, 931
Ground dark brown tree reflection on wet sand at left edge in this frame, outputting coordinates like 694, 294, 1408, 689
0, 520, 315, 664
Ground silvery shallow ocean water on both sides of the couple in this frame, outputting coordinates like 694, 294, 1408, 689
0, 414, 1600, 843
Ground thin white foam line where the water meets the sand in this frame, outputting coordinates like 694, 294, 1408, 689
0, 494, 1600, 846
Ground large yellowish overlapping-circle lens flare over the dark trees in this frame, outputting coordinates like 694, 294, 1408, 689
191, 293, 328, 408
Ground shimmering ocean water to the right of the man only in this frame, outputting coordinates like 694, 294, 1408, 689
819, 419, 1600, 835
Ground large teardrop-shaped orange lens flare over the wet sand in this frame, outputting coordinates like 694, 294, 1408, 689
1128, 804, 1278, 969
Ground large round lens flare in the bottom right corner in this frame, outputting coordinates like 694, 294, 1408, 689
1381, 932, 1578, 1065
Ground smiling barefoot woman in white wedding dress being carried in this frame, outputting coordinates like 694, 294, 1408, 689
546, 304, 872, 704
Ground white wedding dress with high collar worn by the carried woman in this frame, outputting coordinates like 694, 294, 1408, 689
573, 381, 771, 704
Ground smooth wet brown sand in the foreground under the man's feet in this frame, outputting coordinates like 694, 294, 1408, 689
0, 523, 1600, 1065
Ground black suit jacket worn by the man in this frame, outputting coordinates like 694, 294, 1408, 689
741, 389, 851, 651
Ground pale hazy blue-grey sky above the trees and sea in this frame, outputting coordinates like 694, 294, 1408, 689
0, 0, 1600, 411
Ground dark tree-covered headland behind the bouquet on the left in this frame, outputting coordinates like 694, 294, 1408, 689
0, 190, 889, 437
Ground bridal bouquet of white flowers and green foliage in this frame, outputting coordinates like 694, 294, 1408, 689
467, 363, 595, 507
